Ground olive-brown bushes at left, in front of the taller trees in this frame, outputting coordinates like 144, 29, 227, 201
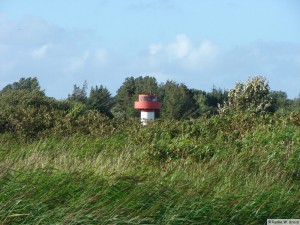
0, 90, 113, 141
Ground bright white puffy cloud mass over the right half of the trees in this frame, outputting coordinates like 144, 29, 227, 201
141, 35, 300, 98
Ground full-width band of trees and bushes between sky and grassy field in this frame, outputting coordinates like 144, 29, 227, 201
0, 76, 300, 140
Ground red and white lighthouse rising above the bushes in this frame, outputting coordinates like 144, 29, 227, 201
134, 94, 161, 125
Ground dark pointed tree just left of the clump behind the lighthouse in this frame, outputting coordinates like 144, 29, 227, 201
87, 85, 114, 118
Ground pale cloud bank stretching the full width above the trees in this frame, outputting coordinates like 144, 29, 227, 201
0, 14, 300, 98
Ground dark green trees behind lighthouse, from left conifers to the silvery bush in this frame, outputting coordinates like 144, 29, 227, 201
67, 76, 227, 120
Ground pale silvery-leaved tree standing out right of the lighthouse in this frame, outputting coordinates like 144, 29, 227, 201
219, 76, 272, 114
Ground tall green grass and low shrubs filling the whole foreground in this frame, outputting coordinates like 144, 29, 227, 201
0, 115, 300, 224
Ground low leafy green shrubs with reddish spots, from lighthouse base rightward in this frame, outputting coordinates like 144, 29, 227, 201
134, 113, 300, 163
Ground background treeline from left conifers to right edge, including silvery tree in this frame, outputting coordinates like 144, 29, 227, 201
59, 76, 300, 120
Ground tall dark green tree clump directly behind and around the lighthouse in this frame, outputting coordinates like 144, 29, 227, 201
112, 76, 227, 120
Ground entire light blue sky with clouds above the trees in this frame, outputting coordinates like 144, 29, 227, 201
0, 0, 300, 99
